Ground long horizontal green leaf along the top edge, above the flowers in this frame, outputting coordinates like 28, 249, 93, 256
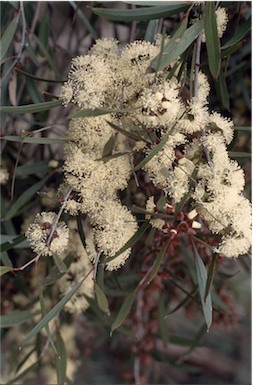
92, 3, 190, 21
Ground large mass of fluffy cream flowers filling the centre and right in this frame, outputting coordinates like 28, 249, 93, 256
57, 38, 251, 262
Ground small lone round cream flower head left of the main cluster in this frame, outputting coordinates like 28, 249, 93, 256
25, 211, 69, 256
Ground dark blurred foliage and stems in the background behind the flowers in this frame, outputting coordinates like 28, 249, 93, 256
1, 1, 251, 384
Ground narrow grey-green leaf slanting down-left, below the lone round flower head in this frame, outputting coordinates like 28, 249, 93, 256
23, 277, 85, 344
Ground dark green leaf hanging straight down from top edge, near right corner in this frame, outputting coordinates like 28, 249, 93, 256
204, 1, 221, 79
